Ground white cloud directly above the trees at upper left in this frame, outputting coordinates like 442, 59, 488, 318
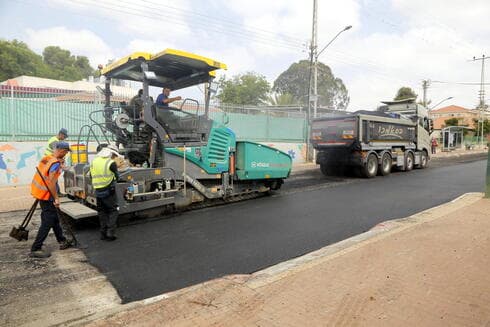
25, 26, 114, 67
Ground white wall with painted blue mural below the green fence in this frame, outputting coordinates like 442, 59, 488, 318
0, 142, 306, 186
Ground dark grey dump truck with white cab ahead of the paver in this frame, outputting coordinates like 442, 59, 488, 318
311, 99, 432, 178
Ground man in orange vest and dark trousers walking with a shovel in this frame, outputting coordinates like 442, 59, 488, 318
30, 141, 72, 258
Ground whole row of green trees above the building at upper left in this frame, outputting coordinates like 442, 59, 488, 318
0, 40, 94, 81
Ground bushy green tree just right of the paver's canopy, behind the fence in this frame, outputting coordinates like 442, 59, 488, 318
217, 72, 270, 105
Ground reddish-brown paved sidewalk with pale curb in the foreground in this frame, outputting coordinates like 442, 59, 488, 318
78, 193, 490, 326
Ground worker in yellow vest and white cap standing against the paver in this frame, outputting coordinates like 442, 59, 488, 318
90, 145, 119, 241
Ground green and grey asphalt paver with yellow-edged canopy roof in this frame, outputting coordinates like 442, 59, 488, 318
61, 49, 292, 219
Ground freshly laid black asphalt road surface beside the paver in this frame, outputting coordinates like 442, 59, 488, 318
78, 159, 486, 302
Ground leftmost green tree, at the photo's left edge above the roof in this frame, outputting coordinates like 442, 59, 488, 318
0, 40, 49, 81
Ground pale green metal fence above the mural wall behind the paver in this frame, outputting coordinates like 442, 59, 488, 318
0, 90, 307, 143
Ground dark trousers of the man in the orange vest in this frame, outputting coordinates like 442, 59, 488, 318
31, 201, 66, 251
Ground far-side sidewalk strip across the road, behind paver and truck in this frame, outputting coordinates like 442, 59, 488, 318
0, 149, 487, 212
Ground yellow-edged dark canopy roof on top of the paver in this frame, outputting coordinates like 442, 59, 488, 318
102, 49, 226, 90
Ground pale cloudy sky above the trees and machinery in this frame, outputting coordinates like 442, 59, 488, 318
0, 0, 490, 110
